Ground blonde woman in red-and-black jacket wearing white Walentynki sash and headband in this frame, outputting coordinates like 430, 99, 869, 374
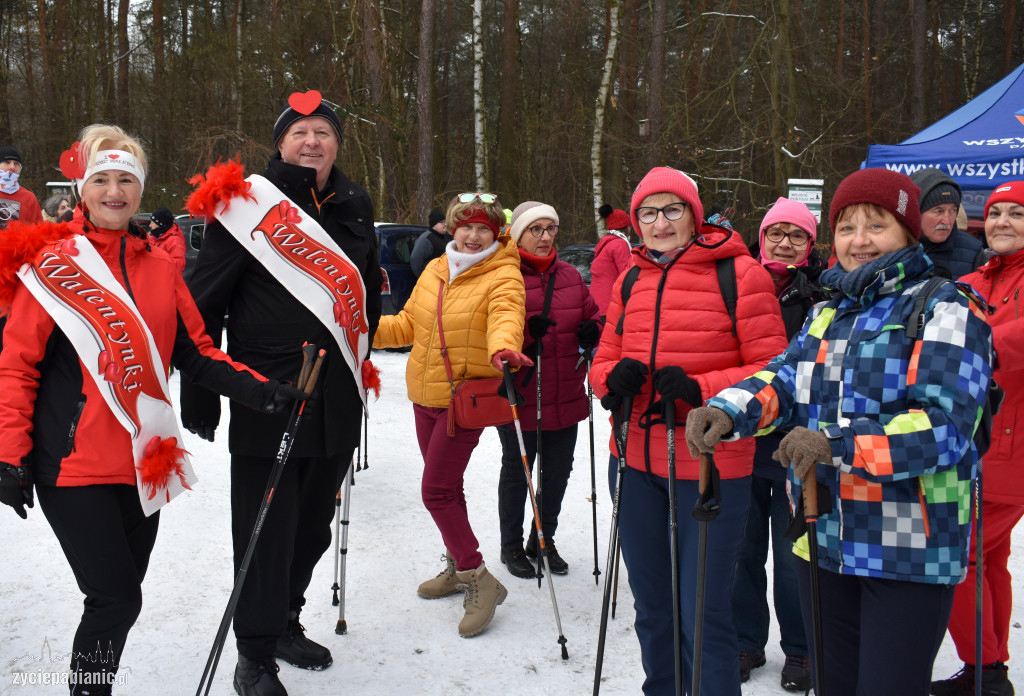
0, 125, 301, 695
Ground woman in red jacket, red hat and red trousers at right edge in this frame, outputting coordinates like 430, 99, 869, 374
932, 181, 1024, 696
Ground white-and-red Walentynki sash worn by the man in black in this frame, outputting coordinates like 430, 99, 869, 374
214, 174, 370, 405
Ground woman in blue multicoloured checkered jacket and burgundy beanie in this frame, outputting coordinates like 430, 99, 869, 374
686, 169, 992, 696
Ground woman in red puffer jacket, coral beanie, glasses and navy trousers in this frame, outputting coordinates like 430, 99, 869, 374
590, 167, 786, 696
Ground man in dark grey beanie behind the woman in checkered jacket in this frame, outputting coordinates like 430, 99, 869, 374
910, 167, 988, 280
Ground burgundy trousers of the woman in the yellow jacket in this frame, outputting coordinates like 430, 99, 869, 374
413, 403, 483, 570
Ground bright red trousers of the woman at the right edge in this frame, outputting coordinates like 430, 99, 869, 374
949, 501, 1024, 664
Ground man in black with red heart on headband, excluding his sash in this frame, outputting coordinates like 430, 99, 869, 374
181, 92, 381, 696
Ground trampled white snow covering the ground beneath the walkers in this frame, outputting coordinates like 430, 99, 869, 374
0, 352, 1024, 696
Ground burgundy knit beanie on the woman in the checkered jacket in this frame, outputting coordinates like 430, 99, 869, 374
828, 168, 921, 240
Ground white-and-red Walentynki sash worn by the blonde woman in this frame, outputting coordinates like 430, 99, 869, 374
18, 234, 197, 515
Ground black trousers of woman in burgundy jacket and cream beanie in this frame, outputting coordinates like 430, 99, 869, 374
498, 424, 579, 551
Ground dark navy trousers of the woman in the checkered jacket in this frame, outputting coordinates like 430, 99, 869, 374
797, 559, 955, 696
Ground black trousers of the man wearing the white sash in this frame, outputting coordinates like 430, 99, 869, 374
231, 451, 352, 660
